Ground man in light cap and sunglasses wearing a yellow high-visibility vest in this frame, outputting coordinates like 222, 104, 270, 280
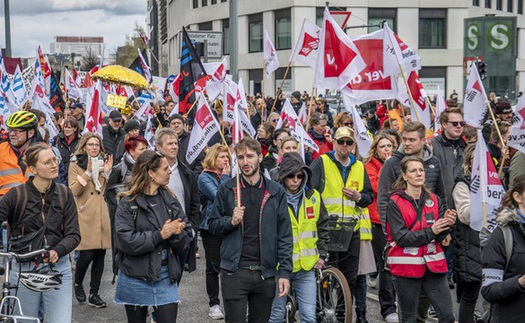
311, 127, 374, 321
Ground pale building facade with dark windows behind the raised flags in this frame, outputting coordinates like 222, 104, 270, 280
167, 0, 525, 99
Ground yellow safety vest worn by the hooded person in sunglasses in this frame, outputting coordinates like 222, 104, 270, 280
288, 191, 321, 273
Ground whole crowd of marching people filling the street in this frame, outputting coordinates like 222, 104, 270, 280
0, 91, 525, 323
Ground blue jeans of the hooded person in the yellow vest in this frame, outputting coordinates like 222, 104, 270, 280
268, 270, 317, 323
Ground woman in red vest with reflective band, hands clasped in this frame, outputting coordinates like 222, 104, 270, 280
386, 156, 456, 323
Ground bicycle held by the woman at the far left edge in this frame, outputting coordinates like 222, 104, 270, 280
0, 247, 55, 323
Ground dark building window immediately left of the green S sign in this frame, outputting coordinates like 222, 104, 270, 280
419, 9, 447, 48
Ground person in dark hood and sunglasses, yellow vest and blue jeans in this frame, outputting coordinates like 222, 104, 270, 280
268, 152, 329, 323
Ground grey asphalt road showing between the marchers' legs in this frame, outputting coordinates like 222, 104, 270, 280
70, 242, 466, 323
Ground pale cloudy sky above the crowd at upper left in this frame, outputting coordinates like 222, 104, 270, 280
0, 0, 147, 57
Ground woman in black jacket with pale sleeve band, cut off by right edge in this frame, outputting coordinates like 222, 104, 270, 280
481, 175, 525, 322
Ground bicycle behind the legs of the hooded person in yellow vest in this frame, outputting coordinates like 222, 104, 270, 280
284, 267, 352, 323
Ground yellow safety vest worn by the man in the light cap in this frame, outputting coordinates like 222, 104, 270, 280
321, 154, 372, 240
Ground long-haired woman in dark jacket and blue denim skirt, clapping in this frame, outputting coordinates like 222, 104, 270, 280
115, 150, 192, 323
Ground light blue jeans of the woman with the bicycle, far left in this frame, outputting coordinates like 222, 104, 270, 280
10, 255, 73, 323
